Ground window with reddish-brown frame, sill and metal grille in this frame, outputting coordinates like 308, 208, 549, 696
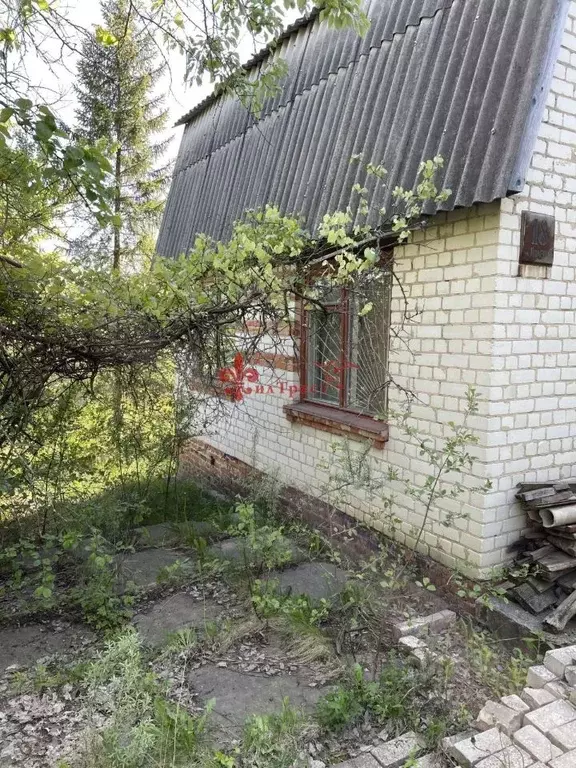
286, 258, 391, 448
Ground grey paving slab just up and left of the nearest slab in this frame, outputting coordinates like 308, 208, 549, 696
132, 592, 222, 646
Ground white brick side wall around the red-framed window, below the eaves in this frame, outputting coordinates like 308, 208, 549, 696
190, 203, 505, 572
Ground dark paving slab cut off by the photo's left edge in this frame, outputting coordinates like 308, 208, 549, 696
0, 622, 95, 673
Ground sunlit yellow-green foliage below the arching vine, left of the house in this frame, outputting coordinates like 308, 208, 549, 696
0, 359, 180, 532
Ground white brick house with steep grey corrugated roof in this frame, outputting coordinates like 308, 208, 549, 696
158, 0, 576, 576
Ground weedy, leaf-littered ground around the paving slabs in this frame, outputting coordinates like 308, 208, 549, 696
0, 481, 536, 768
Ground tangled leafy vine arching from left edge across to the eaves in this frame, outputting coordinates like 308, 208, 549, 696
0, 158, 449, 452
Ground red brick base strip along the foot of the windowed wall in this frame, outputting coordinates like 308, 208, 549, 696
179, 440, 474, 613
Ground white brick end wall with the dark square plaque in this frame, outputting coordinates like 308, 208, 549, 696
485, 0, 576, 565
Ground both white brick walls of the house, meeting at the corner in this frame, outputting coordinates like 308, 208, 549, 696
183, 0, 576, 575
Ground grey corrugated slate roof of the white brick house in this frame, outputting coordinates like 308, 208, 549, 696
158, 0, 567, 256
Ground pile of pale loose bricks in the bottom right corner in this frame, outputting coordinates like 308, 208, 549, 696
335, 645, 576, 768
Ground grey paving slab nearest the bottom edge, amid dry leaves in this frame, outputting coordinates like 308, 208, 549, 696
188, 664, 327, 738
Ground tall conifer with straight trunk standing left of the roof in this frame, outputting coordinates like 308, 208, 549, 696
76, 0, 169, 270
